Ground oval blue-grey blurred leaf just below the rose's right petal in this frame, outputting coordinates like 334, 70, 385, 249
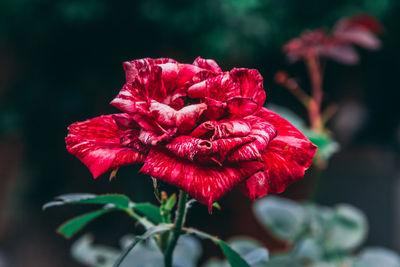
253, 196, 306, 241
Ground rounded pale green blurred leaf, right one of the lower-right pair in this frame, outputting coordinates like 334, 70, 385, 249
325, 204, 368, 251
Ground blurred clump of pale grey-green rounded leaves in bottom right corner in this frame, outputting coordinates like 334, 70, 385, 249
253, 196, 400, 267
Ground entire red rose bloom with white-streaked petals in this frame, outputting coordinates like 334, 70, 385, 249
66, 58, 316, 210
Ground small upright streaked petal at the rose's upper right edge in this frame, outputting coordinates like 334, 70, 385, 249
229, 68, 266, 106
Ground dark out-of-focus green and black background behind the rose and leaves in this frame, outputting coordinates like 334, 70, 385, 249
0, 0, 400, 267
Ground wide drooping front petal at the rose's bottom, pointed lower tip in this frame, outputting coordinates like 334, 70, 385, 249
140, 148, 263, 206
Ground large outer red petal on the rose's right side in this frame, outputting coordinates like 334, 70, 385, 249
240, 108, 317, 199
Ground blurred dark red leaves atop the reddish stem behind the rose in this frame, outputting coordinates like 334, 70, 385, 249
283, 14, 383, 65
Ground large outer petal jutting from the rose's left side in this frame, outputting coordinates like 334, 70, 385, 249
65, 114, 145, 178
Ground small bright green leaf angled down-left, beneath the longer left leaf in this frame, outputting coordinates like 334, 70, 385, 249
57, 209, 112, 238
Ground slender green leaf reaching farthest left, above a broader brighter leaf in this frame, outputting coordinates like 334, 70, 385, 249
43, 193, 131, 209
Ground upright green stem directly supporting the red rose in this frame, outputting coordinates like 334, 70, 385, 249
164, 190, 187, 267
